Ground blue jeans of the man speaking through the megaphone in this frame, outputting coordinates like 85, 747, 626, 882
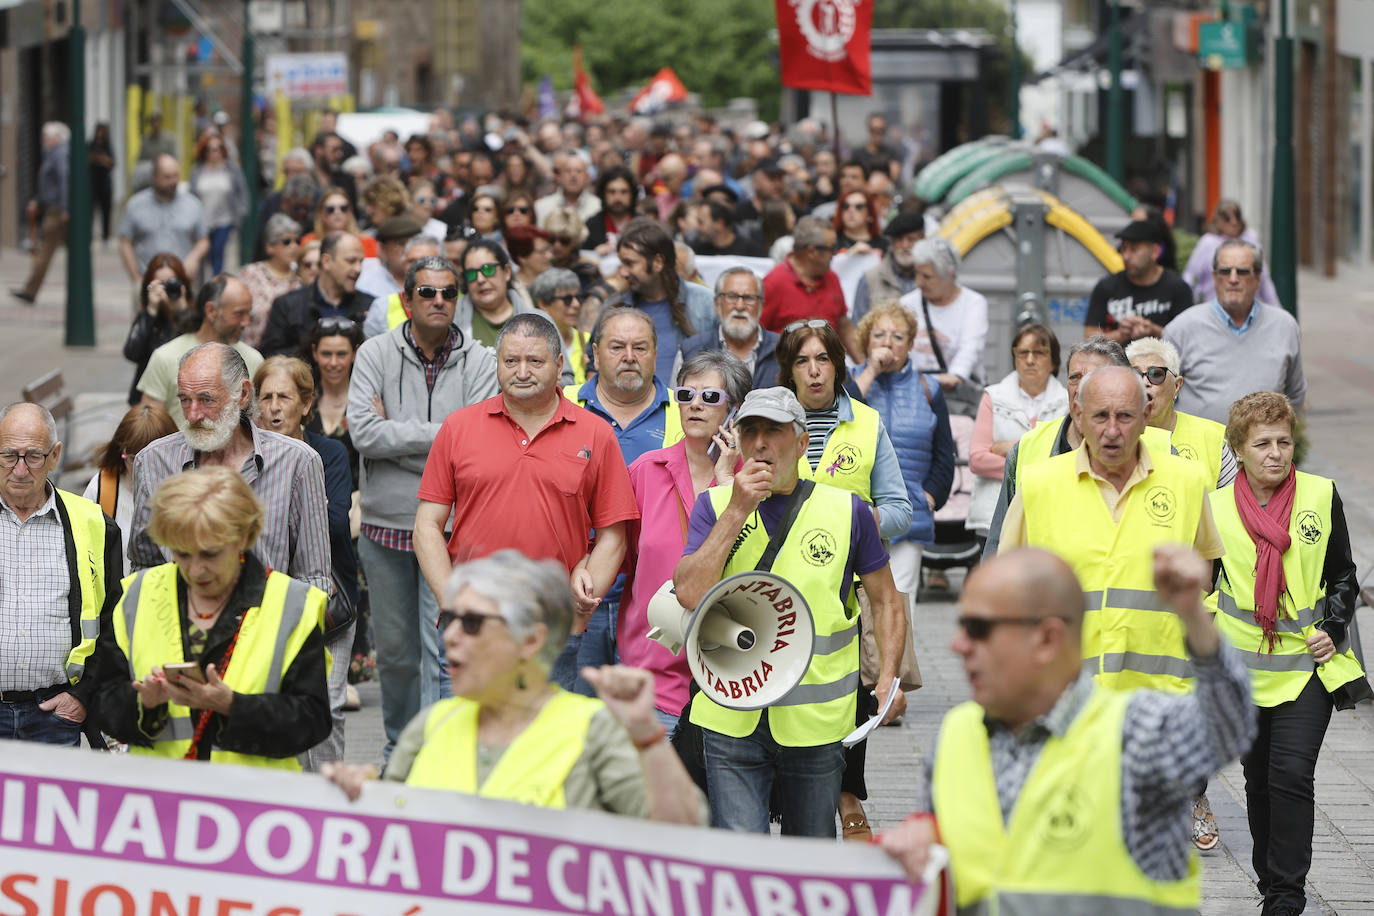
702, 710, 845, 839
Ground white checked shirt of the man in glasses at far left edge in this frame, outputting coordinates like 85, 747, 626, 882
0, 483, 71, 691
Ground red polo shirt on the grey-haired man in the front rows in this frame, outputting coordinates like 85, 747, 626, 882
419, 394, 639, 573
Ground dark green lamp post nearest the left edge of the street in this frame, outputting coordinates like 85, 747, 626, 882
65, 0, 95, 346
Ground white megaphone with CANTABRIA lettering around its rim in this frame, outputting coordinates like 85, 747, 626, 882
647, 571, 816, 710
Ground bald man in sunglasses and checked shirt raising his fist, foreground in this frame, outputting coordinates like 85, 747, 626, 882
879, 544, 1254, 913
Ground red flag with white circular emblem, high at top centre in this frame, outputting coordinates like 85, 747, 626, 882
774, 0, 874, 95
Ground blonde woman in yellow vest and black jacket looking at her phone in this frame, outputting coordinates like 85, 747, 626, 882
92, 467, 331, 770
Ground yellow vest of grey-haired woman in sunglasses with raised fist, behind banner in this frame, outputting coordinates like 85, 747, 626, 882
405, 687, 605, 808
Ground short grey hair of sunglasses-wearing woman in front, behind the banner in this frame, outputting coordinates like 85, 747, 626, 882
444, 548, 573, 674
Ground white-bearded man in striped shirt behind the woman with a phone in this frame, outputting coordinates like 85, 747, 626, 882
129, 342, 334, 595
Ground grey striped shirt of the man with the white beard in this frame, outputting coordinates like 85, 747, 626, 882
129, 423, 334, 595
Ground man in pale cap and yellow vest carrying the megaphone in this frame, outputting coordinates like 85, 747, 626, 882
673, 387, 907, 838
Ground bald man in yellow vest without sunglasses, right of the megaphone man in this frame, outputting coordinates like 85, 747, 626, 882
999, 365, 1223, 694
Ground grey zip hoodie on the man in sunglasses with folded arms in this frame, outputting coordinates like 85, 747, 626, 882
348, 321, 500, 531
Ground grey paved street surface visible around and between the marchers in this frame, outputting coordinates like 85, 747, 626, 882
0, 250, 1374, 916
